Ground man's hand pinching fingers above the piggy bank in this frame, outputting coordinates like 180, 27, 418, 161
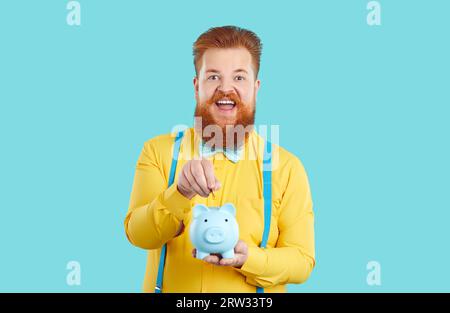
177, 160, 220, 199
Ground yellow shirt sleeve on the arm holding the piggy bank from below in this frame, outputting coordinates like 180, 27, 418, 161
236, 158, 315, 288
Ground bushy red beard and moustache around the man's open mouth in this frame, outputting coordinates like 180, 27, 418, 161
194, 91, 256, 150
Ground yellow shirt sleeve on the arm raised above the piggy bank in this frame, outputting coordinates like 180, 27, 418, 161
124, 140, 191, 249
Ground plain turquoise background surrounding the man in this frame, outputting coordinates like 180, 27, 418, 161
0, 0, 450, 292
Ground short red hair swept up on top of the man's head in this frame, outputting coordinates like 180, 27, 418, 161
193, 26, 262, 77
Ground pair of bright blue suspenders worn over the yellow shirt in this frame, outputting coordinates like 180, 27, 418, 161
155, 131, 272, 293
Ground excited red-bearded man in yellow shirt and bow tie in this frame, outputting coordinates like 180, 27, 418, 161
125, 26, 315, 292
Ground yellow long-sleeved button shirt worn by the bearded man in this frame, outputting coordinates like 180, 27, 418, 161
125, 128, 315, 293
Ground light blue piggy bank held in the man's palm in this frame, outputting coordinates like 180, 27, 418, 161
189, 203, 239, 259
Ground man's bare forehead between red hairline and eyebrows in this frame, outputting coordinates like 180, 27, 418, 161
200, 48, 253, 72
